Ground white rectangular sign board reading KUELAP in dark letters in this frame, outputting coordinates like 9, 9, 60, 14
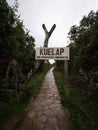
35, 47, 69, 60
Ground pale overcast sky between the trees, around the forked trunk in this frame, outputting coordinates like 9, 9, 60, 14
7, 0, 98, 47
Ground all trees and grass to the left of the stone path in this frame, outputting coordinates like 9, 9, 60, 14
0, 0, 49, 129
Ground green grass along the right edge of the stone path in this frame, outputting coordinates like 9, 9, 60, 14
54, 70, 98, 130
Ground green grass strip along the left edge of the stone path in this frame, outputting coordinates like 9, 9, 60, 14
0, 67, 49, 129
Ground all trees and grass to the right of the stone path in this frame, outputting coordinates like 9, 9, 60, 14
55, 11, 98, 130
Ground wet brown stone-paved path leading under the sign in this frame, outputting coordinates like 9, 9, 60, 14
17, 68, 72, 130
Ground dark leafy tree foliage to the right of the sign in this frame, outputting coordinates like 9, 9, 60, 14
69, 11, 98, 71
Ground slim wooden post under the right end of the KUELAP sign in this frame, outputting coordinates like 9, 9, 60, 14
64, 60, 69, 97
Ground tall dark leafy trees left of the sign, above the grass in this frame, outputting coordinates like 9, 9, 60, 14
0, 0, 35, 103
